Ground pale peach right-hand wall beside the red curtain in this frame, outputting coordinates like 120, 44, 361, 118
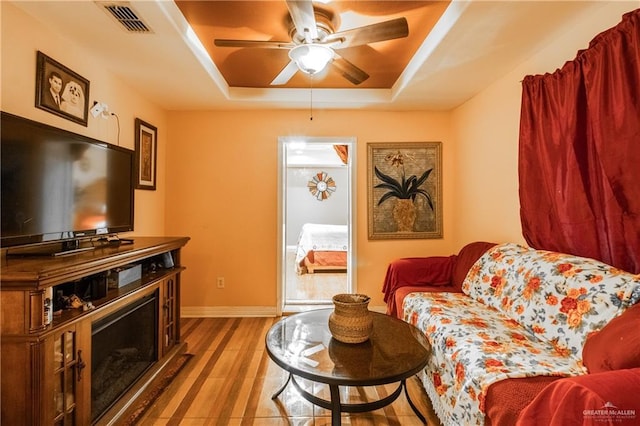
452, 2, 638, 246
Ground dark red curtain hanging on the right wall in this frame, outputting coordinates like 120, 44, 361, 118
519, 9, 640, 273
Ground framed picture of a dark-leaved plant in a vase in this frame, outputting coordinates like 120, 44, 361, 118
367, 142, 442, 240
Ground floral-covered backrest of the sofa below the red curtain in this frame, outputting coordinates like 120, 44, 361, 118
462, 243, 640, 358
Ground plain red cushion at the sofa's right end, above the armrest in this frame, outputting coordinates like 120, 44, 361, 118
582, 303, 640, 373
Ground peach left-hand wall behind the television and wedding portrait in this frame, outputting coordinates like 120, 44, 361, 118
0, 2, 167, 235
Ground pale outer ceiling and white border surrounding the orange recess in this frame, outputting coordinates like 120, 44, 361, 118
12, 0, 638, 110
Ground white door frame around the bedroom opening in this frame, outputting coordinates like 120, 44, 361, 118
276, 136, 357, 316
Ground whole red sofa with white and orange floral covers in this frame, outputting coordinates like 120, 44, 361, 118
384, 243, 640, 425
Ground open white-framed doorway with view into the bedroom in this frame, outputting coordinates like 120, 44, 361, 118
277, 137, 355, 314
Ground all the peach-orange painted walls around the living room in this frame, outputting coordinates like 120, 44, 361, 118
6, 2, 631, 311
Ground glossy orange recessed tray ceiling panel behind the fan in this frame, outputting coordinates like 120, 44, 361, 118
176, 0, 449, 89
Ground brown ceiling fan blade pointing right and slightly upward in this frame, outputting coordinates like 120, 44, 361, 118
326, 18, 409, 49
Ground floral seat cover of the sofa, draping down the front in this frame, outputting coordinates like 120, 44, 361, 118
403, 292, 586, 425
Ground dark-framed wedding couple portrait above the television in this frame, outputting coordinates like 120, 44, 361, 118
36, 51, 89, 126
